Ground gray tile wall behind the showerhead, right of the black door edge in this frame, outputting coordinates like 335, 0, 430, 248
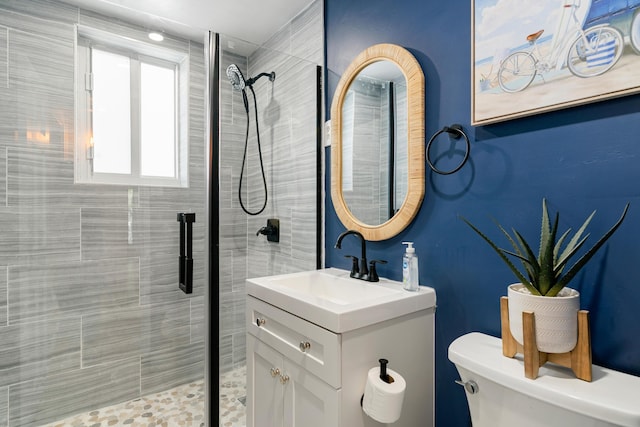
219, 0, 323, 372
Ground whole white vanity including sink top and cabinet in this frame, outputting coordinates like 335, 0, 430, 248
246, 268, 436, 427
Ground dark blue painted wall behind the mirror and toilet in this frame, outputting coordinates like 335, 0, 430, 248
325, 0, 640, 427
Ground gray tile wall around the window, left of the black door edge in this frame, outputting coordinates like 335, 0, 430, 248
0, 0, 206, 427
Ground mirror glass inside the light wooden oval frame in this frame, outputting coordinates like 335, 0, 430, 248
341, 61, 408, 225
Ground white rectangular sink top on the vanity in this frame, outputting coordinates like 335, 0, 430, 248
247, 268, 436, 333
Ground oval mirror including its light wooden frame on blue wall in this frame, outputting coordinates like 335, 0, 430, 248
331, 44, 425, 240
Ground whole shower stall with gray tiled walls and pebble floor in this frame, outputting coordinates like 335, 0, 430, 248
0, 0, 322, 427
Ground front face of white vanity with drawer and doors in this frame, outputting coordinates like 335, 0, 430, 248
247, 297, 340, 427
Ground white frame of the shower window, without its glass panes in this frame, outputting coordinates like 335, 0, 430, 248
75, 26, 189, 187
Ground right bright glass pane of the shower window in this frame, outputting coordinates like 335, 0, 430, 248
140, 62, 176, 177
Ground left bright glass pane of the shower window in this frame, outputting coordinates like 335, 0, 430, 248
91, 49, 131, 174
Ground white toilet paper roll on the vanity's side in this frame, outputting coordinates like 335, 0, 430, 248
362, 367, 407, 423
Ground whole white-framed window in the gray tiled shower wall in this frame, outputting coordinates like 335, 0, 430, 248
76, 28, 188, 187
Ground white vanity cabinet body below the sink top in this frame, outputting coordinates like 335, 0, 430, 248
246, 279, 435, 427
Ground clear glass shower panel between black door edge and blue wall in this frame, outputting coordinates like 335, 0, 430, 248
218, 27, 321, 427
